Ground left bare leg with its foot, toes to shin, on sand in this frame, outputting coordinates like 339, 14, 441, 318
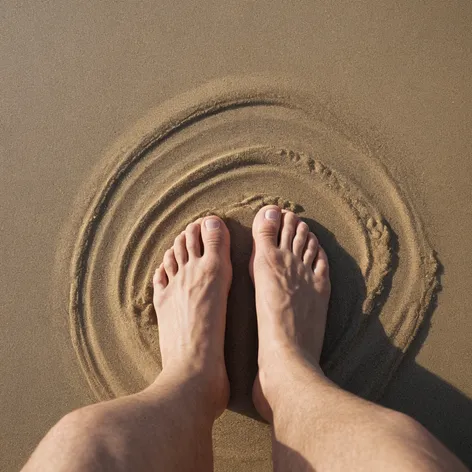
24, 216, 231, 472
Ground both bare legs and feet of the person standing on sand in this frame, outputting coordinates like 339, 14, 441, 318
23, 206, 467, 472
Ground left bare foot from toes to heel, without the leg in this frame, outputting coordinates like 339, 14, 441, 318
153, 216, 232, 417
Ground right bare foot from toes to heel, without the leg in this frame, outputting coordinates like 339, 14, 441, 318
250, 205, 331, 422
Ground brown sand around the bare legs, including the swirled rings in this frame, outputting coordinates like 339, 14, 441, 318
0, 2, 472, 471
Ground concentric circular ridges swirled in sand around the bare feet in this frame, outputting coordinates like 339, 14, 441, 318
66, 81, 437, 468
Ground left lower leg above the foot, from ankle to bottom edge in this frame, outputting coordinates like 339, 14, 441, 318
24, 371, 216, 472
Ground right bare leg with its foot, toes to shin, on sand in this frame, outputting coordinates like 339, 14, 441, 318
250, 206, 466, 472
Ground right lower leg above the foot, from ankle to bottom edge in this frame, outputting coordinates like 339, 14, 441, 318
265, 352, 466, 472
